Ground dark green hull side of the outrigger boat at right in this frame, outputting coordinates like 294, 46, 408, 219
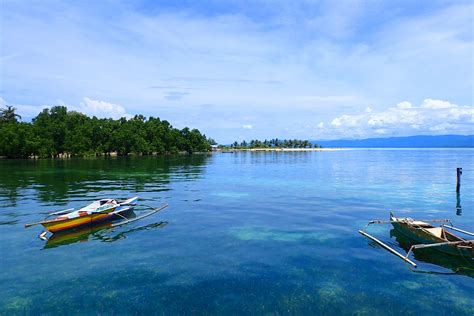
391, 221, 474, 259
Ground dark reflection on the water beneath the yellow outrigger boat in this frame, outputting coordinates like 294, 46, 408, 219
43, 210, 168, 249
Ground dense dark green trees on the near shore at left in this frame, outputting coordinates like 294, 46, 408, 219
0, 106, 212, 158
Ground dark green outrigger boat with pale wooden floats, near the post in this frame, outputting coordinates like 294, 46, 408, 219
359, 213, 474, 268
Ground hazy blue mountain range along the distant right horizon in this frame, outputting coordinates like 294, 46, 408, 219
311, 135, 474, 148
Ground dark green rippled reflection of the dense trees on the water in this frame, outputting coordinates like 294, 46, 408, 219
0, 154, 211, 206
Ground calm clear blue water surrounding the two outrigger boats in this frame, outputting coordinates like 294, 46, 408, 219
0, 150, 474, 315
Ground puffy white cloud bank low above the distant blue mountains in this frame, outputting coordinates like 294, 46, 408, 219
318, 99, 474, 138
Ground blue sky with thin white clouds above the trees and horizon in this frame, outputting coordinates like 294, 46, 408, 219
0, 0, 474, 143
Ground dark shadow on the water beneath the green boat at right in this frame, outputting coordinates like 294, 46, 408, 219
390, 228, 474, 278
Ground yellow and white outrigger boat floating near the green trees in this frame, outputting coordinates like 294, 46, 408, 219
25, 197, 168, 237
